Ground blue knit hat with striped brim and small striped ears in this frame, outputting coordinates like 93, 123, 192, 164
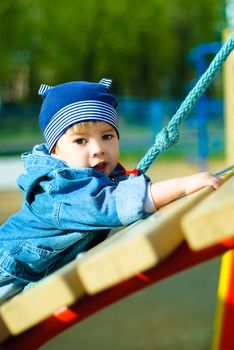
38, 79, 119, 152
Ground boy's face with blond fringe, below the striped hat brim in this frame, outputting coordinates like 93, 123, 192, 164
51, 122, 119, 175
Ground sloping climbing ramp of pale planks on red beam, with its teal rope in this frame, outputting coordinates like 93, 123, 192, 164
0, 31, 234, 350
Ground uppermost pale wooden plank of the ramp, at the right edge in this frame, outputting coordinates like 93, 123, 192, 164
182, 172, 234, 250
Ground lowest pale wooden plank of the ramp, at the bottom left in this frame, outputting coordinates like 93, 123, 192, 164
0, 262, 84, 341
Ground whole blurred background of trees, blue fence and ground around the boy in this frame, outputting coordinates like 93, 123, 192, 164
0, 0, 234, 350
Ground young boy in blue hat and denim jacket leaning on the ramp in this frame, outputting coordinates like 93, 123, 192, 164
0, 79, 221, 302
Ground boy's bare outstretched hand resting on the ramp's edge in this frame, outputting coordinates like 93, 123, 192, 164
183, 172, 223, 194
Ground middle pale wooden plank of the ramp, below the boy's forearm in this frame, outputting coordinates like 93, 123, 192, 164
77, 188, 215, 295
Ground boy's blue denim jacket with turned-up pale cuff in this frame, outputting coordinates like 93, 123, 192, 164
0, 144, 150, 284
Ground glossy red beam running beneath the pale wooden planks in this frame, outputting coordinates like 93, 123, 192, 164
0, 240, 234, 350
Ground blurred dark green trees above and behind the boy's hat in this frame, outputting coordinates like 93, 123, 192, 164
0, 0, 225, 98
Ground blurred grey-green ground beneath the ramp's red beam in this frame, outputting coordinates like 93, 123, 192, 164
41, 259, 219, 350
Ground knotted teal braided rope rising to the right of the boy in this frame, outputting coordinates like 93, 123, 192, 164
137, 34, 234, 173
